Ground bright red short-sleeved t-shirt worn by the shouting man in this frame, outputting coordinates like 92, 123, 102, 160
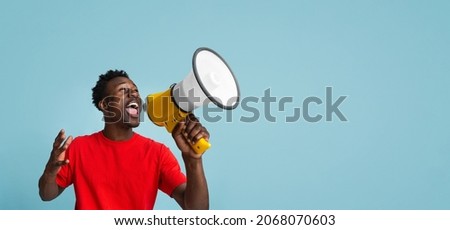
56, 131, 186, 210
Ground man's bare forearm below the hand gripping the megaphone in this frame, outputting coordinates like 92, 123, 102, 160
184, 158, 209, 209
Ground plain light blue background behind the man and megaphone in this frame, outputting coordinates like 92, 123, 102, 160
0, 0, 450, 209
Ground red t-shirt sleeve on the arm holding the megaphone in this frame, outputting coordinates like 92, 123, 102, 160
159, 146, 186, 196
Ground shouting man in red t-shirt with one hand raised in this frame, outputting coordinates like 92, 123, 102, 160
39, 70, 209, 210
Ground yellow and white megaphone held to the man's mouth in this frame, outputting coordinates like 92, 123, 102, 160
146, 47, 240, 154
